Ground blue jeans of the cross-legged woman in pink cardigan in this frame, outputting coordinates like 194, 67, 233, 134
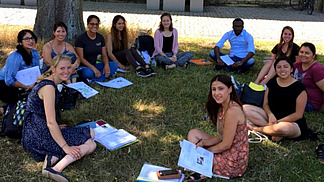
155, 52, 193, 67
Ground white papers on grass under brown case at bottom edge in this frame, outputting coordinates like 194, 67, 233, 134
136, 163, 184, 182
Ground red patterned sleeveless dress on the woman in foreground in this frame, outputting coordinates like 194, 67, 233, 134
213, 102, 249, 178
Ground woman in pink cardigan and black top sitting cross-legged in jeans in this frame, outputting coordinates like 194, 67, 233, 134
152, 13, 193, 69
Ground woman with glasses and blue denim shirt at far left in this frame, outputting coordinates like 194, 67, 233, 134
0, 29, 39, 116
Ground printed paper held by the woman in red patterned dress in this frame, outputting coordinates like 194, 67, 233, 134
178, 140, 214, 178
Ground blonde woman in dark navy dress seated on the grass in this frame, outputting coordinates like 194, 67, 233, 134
22, 55, 96, 181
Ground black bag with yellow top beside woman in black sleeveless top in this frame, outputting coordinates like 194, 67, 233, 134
241, 82, 265, 107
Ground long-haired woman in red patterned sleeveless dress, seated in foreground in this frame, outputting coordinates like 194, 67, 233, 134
187, 75, 249, 181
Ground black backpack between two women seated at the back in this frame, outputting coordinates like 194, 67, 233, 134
134, 35, 154, 57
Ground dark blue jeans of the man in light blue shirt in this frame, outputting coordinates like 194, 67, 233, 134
209, 50, 255, 72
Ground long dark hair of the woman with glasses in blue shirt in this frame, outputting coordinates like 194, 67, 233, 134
16, 29, 37, 66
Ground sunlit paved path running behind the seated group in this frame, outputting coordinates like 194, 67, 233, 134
0, 1, 324, 44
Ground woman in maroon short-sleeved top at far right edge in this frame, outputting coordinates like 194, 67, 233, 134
294, 42, 324, 112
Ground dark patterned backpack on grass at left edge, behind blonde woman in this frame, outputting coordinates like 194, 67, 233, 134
2, 98, 27, 139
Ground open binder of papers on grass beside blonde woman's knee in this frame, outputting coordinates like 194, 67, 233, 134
93, 120, 138, 150
